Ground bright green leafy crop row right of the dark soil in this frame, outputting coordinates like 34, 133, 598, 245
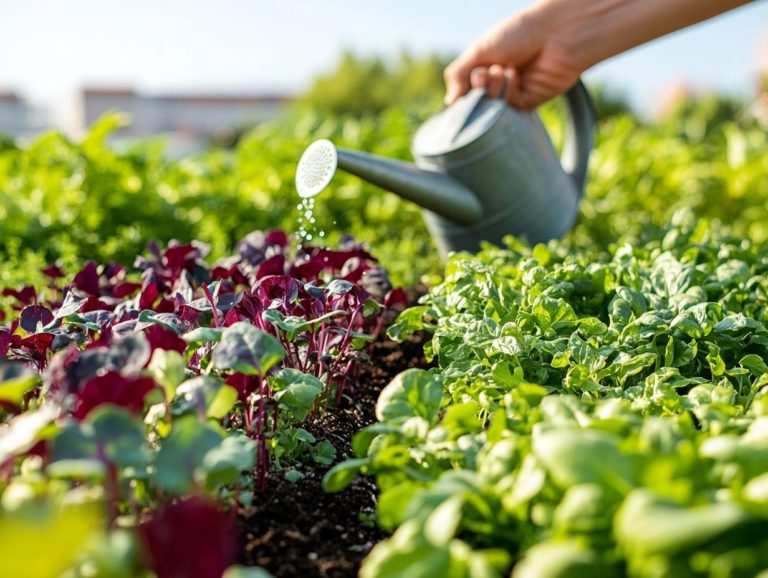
325, 215, 768, 578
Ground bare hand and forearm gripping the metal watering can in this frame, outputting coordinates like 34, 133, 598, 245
444, 0, 749, 109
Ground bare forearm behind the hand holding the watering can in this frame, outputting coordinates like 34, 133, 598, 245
528, 0, 749, 69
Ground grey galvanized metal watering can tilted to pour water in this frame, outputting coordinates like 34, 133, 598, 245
296, 81, 595, 255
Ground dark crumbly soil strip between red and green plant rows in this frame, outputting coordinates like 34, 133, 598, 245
238, 328, 436, 578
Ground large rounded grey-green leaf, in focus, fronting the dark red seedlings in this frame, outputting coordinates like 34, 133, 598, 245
213, 321, 285, 376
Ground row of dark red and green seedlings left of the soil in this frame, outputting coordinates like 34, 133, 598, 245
0, 231, 405, 578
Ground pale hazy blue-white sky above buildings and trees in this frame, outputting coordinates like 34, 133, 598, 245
0, 0, 768, 118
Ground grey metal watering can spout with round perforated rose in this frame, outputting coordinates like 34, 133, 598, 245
296, 140, 483, 225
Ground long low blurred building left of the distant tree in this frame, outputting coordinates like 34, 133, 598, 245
74, 87, 292, 140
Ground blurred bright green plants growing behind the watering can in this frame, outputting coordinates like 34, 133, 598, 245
0, 99, 768, 287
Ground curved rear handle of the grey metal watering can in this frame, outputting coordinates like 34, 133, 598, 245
561, 80, 595, 198
